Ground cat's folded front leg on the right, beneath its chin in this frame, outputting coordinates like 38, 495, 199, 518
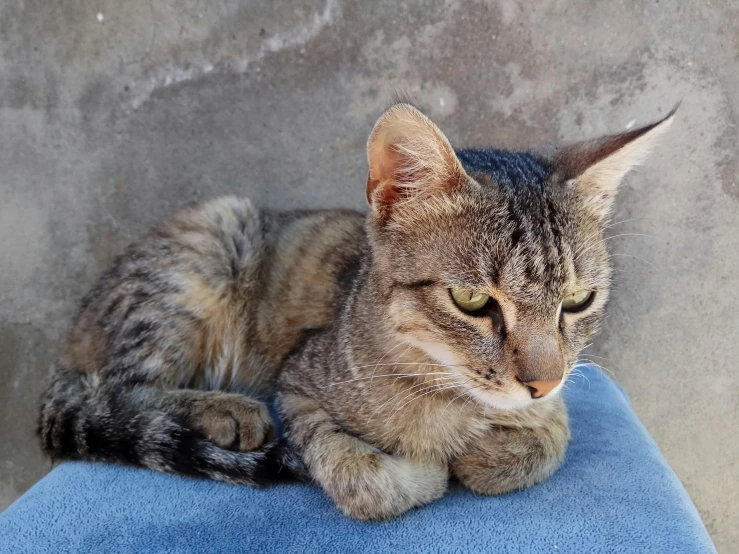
452, 398, 570, 495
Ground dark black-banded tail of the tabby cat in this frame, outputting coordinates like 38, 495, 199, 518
37, 372, 310, 486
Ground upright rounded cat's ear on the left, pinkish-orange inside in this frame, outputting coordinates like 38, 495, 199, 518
367, 103, 465, 219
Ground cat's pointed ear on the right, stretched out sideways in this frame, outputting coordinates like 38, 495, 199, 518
551, 104, 679, 219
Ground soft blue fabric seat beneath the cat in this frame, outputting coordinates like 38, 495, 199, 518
0, 367, 715, 554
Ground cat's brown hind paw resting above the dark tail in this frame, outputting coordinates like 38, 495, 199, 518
192, 394, 275, 451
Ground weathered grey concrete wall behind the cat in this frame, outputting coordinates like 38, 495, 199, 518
0, 0, 739, 552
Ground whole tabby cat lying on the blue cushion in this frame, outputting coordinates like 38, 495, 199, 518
38, 102, 675, 520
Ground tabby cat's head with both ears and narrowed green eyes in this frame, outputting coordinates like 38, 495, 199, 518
367, 103, 674, 409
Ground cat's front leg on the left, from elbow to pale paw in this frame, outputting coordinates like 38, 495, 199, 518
281, 393, 448, 520
